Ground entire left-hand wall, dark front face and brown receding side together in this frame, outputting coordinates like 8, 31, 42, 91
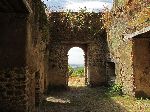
0, 0, 48, 112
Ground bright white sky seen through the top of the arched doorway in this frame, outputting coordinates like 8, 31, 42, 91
68, 47, 84, 65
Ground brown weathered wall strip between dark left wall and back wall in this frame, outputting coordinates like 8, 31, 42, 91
26, 0, 49, 108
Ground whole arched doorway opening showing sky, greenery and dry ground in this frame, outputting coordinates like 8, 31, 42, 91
68, 47, 86, 87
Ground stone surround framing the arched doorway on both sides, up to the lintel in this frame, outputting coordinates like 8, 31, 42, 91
48, 41, 106, 88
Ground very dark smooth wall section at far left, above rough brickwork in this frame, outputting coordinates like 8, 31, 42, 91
0, 13, 26, 68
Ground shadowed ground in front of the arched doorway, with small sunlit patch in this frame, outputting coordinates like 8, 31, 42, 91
44, 87, 128, 112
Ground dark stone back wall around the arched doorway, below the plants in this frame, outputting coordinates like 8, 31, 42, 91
48, 13, 107, 87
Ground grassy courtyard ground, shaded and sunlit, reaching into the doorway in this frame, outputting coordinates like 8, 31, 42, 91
45, 79, 150, 112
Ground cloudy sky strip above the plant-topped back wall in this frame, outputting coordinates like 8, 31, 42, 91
42, 0, 112, 12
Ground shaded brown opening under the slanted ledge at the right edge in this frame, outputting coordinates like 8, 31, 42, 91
132, 32, 150, 98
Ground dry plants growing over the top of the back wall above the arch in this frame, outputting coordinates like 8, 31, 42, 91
62, 7, 102, 36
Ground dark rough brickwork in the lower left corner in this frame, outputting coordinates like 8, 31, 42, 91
0, 69, 29, 112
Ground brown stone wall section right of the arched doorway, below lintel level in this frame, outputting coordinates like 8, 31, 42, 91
87, 42, 106, 86
